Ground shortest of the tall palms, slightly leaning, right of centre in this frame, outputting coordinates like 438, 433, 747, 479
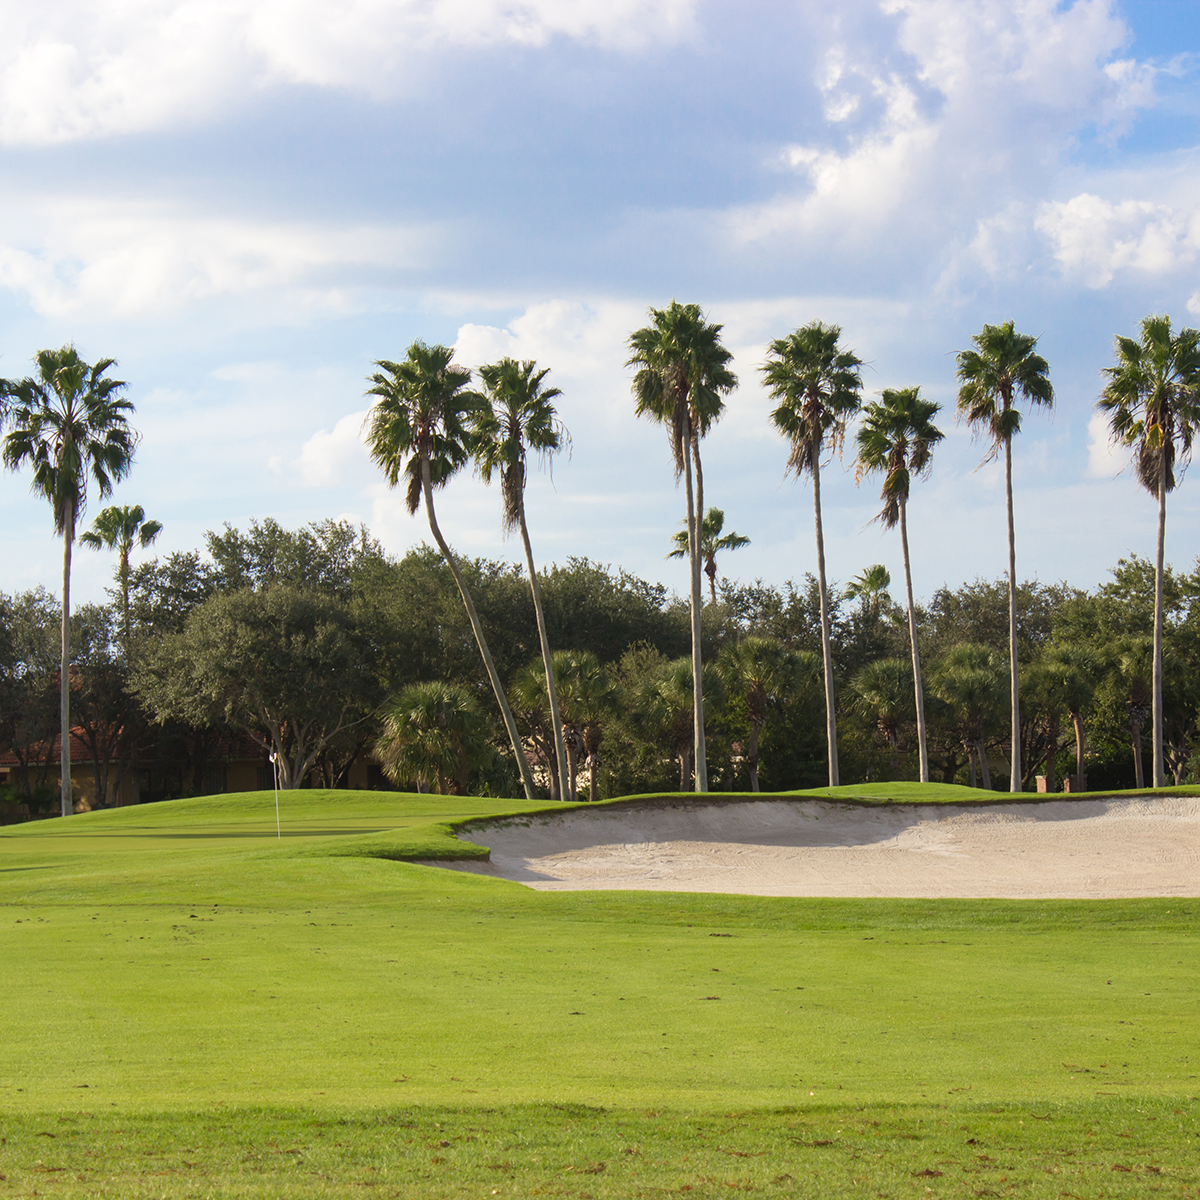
856, 388, 943, 784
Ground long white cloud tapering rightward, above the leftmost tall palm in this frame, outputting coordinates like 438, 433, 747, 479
0, 199, 440, 317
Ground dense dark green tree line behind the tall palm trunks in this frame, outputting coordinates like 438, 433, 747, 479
0, 521, 1200, 808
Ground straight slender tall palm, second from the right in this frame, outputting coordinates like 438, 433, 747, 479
958, 322, 1054, 792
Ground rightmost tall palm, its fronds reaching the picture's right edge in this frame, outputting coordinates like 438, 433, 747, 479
1096, 317, 1200, 787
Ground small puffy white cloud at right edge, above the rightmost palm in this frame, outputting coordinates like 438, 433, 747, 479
1034, 192, 1200, 288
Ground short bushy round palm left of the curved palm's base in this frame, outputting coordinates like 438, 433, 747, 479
374, 682, 492, 796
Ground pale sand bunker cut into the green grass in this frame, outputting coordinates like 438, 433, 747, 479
437, 797, 1200, 899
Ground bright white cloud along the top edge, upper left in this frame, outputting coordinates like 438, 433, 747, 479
0, 0, 694, 144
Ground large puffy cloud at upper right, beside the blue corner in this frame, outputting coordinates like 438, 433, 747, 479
722, 0, 1154, 275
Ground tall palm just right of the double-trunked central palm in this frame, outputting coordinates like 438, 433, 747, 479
761, 320, 863, 787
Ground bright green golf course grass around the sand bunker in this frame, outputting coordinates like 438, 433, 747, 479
0, 785, 1200, 1198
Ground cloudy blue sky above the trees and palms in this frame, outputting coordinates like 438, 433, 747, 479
0, 0, 1200, 609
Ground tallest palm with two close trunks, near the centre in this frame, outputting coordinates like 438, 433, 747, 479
625, 300, 738, 792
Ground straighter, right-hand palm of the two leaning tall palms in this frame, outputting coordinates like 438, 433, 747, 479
468, 359, 574, 798
